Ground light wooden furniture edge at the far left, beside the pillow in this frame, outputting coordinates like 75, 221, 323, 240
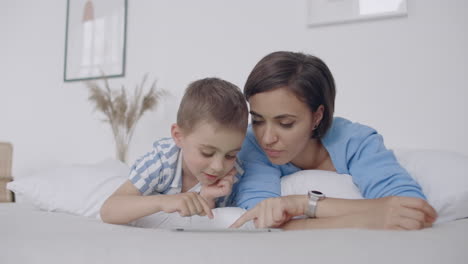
0, 142, 14, 202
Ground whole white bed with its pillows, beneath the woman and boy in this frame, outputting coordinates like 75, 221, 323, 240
0, 148, 468, 264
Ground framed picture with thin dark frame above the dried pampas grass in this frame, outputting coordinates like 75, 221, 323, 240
63, 0, 127, 82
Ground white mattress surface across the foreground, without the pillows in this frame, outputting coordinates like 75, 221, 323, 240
0, 204, 468, 264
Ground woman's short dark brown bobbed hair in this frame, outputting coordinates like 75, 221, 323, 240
244, 51, 336, 138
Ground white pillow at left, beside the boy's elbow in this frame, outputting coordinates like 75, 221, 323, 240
7, 159, 129, 219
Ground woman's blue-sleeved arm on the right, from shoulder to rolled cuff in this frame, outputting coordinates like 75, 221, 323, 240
328, 118, 426, 199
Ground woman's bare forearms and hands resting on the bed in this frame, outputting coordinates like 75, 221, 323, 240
232, 195, 437, 229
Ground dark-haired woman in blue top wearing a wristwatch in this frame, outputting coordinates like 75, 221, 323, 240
232, 52, 437, 230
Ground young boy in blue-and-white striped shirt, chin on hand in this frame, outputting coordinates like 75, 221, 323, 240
101, 78, 248, 224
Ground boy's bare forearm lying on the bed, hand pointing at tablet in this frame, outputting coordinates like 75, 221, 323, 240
100, 180, 213, 224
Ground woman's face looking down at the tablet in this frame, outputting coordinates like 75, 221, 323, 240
249, 88, 322, 165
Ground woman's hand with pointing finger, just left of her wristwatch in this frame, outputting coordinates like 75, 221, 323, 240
230, 195, 307, 228
